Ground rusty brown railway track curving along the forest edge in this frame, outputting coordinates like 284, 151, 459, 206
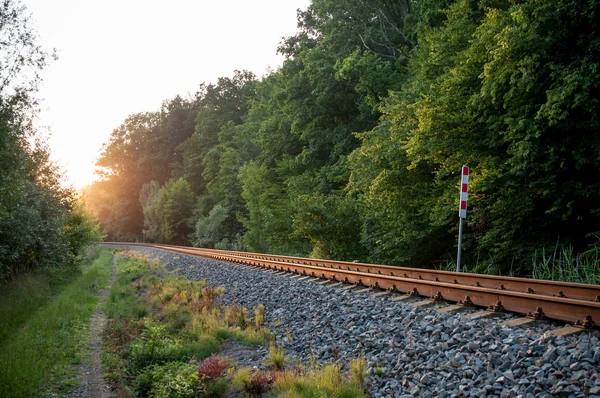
106, 242, 600, 334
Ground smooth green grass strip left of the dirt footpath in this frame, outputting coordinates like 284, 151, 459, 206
0, 250, 112, 397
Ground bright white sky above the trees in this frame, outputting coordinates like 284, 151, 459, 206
23, 0, 309, 188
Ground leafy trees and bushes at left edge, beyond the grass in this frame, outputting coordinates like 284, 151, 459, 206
0, 0, 100, 283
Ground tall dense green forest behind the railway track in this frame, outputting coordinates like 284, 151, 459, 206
86, 0, 600, 276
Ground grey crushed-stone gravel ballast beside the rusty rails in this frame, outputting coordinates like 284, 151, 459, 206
113, 246, 600, 398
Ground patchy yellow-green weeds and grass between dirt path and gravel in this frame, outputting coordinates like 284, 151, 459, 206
103, 252, 366, 397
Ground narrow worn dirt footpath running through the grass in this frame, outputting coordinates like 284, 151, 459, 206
65, 257, 117, 398
